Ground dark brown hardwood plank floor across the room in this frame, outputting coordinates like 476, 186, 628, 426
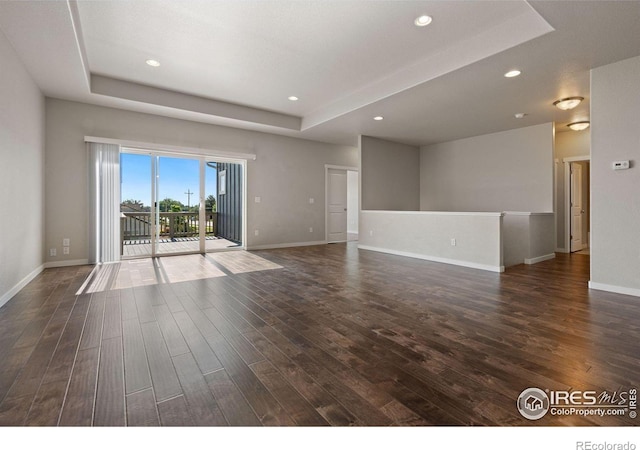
0, 243, 640, 426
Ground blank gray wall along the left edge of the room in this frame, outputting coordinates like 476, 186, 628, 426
0, 32, 44, 306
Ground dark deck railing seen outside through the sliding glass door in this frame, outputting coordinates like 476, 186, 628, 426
120, 212, 217, 241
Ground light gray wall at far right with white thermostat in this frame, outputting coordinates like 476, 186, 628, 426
591, 57, 640, 295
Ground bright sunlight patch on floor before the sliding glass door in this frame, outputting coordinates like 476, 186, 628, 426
77, 251, 282, 295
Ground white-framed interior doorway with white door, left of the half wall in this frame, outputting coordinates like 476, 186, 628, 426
325, 165, 359, 243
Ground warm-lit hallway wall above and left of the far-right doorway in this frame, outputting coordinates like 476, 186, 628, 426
555, 128, 591, 252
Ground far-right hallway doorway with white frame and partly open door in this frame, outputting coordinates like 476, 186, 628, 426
564, 157, 591, 254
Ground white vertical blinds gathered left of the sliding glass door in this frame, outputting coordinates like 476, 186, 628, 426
88, 142, 121, 264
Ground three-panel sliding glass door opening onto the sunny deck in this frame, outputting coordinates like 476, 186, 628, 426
121, 150, 244, 258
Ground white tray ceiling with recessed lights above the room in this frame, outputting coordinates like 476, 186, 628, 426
0, 0, 640, 145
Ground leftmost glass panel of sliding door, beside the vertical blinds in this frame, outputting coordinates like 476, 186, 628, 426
120, 153, 154, 258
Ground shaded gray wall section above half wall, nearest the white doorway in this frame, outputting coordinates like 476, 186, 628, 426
360, 136, 420, 211
